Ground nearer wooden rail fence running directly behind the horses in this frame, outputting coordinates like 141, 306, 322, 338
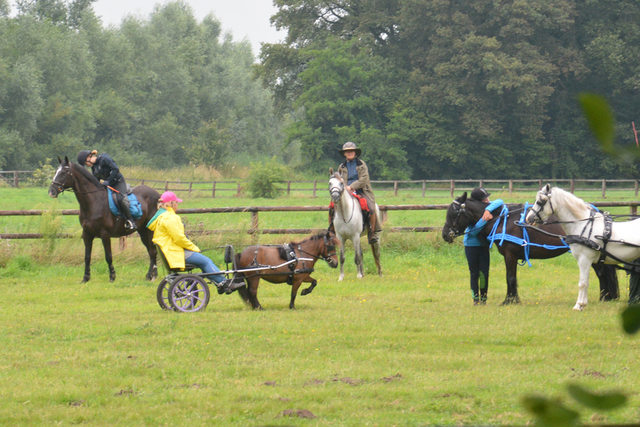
0, 201, 640, 239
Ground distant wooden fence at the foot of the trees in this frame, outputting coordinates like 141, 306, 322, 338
0, 171, 640, 198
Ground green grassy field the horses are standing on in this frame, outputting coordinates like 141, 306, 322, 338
0, 189, 640, 426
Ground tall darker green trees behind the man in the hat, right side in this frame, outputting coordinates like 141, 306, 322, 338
259, 0, 640, 179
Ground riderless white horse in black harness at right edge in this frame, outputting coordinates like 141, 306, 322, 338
526, 184, 640, 310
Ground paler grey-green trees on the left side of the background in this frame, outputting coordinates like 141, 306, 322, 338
0, 0, 282, 170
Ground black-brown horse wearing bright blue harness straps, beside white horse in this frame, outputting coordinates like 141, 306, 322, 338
442, 191, 620, 305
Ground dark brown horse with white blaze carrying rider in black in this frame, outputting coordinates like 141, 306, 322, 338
49, 157, 160, 283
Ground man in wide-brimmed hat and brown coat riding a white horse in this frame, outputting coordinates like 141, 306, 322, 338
338, 142, 382, 244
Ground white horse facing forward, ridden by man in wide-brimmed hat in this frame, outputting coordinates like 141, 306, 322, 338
329, 168, 382, 281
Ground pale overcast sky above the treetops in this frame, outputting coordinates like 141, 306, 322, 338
12, 0, 286, 55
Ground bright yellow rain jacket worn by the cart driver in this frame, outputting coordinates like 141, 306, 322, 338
147, 207, 200, 270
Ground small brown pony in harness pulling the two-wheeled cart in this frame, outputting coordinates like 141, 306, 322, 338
234, 230, 340, 310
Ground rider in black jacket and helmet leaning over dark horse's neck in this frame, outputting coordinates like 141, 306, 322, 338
78, 150, 136, 230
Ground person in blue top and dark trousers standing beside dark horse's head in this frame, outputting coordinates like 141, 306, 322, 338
464, 187, 504, 305
